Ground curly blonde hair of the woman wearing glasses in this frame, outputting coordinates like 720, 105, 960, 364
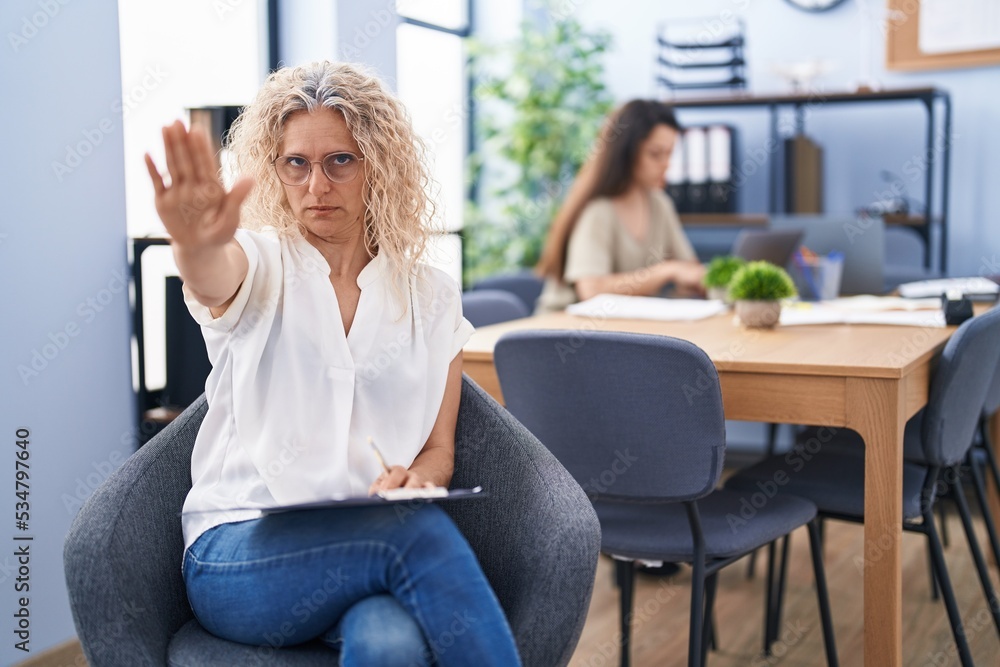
227, 61, 435, 298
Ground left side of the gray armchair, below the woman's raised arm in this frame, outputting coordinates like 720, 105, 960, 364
63, 396, 207, 667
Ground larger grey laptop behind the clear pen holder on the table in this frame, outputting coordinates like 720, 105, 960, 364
771, 214, 885, 294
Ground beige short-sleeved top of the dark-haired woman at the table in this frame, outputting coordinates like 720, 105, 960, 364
535, 190, 697, 314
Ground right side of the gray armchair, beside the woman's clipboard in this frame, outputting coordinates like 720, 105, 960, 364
442, 377, 601, 667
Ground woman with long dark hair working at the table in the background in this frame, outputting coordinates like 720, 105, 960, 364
537, 100, 705, 312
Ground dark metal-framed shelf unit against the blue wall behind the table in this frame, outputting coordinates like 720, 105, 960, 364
668, 88, 951, 273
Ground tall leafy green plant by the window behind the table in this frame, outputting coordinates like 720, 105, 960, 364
464, 2, 612, 283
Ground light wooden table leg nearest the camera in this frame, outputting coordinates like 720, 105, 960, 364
847, 378, 906, 667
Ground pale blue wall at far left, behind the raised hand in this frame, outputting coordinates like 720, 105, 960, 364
0, 0, 134, 664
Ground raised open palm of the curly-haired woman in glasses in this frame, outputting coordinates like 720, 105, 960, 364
146, 121, 253, 248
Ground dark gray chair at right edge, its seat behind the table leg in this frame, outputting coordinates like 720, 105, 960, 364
726, 308, 1000, 666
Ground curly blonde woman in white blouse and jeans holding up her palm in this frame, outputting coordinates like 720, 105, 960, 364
146, 62, 519, 667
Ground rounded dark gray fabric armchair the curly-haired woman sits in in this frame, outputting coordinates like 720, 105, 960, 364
64, 378, 601, 667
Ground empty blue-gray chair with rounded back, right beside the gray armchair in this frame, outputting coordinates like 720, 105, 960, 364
494, 331, 837, 667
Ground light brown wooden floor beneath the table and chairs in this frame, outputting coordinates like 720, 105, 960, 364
570, 511, 1000, 667
